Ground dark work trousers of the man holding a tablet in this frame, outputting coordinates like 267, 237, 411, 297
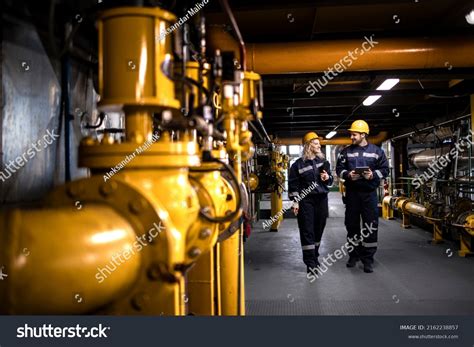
345, 191, 379, 264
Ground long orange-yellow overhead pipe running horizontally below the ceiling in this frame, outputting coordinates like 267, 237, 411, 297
208, 27, 474, 74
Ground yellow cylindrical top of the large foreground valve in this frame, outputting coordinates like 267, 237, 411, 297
98, 7, 179, 111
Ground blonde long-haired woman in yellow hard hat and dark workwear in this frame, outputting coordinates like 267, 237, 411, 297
288, 132, 333, 273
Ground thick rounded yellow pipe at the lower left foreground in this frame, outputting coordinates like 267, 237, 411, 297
0, 204, 141, 314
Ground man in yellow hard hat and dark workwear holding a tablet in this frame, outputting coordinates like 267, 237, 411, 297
336, 120, 389, 273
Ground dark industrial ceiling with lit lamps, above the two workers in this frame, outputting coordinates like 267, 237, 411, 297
207, 0, 474, 138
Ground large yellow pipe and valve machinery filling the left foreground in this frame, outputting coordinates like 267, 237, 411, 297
0, 3, 261, 315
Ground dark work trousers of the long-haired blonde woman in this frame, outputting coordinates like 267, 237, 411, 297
297, 193, 328, 267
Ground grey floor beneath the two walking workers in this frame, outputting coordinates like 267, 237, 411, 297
245, 193, 474, 315
